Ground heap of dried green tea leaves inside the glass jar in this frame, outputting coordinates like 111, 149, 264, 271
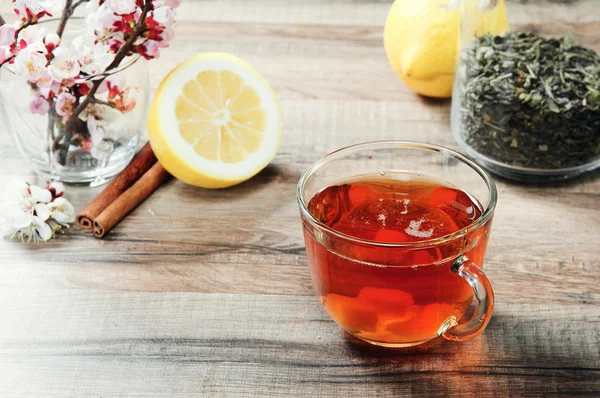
457, 32, 600, 169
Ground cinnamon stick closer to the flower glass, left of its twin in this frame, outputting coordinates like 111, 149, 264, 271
75, 143, 156, 229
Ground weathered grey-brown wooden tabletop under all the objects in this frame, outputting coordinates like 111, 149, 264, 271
0, 0, 600, 397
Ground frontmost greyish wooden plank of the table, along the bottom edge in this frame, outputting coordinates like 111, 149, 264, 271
0, 289, 600, 397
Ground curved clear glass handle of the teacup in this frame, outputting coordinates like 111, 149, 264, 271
440, 256, 494, 341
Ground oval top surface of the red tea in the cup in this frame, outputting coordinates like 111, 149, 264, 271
308, 175, 482, 243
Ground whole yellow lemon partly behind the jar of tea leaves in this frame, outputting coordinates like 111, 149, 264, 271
383, 0, 508, 98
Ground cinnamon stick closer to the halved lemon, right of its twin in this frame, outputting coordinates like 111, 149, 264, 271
94, 162, 170, 238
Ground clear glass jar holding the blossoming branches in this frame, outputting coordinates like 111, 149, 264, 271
0, 18, 149, 185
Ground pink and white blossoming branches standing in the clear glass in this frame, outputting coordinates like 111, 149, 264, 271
0, 0, 181, 166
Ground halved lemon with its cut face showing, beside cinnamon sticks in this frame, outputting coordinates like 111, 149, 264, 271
148, 53, 282, 188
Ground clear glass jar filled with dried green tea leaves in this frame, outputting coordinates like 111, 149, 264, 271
451, 0, 600, 181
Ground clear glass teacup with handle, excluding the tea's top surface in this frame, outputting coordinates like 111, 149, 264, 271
297, 141, 497, 347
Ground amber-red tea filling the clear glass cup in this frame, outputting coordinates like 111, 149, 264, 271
305, 174, 489, 345
